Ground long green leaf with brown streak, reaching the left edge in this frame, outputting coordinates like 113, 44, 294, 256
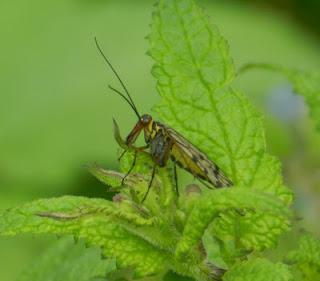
0, 196, 170, 276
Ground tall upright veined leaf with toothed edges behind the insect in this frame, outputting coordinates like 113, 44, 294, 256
149, 0, 292, 250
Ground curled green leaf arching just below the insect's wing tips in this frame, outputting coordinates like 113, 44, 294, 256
176, 187, 289, 256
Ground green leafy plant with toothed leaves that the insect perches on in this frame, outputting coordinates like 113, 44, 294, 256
0, 0, 320, 281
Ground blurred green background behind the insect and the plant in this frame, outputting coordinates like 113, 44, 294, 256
0, 0, 320, 281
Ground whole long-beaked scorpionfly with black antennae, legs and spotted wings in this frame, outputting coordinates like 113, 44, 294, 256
95, 38, 232, 202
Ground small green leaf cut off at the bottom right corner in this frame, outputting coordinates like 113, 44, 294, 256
286, 234, 320, 281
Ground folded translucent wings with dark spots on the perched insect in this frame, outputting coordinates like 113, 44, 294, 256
165, 126, 232, 187
